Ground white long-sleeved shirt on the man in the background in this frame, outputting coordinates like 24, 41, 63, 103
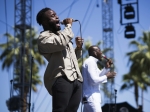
82, 56, 110, 98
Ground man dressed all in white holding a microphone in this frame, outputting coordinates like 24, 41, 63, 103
82, 45, 116, 112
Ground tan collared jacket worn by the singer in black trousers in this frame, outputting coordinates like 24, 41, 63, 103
37, 24, 83, 95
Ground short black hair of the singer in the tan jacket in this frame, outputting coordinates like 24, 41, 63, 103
36, 7, 52, 25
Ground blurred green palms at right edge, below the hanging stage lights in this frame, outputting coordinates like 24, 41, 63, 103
121, 32, 150, 106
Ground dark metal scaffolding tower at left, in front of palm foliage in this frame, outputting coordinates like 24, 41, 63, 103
12, 0, 32, 112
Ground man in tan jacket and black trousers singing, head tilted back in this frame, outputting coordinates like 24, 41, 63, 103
37, 8, 83, 112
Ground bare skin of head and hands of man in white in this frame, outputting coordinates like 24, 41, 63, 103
91, 46, 116, 79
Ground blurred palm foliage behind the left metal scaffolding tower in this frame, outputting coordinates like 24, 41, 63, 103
0, 28, 45, 112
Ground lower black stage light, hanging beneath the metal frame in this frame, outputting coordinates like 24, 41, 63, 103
124, 24, 136, 38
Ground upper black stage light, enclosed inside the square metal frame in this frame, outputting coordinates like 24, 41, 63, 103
124, 4, 135, 19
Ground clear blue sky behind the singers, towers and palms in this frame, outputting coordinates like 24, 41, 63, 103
0, 0, 150, 112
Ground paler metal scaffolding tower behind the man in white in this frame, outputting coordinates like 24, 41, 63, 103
102, 0, 114, 107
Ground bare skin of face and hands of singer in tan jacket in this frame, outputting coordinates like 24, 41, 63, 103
42, 10, 83, 49
